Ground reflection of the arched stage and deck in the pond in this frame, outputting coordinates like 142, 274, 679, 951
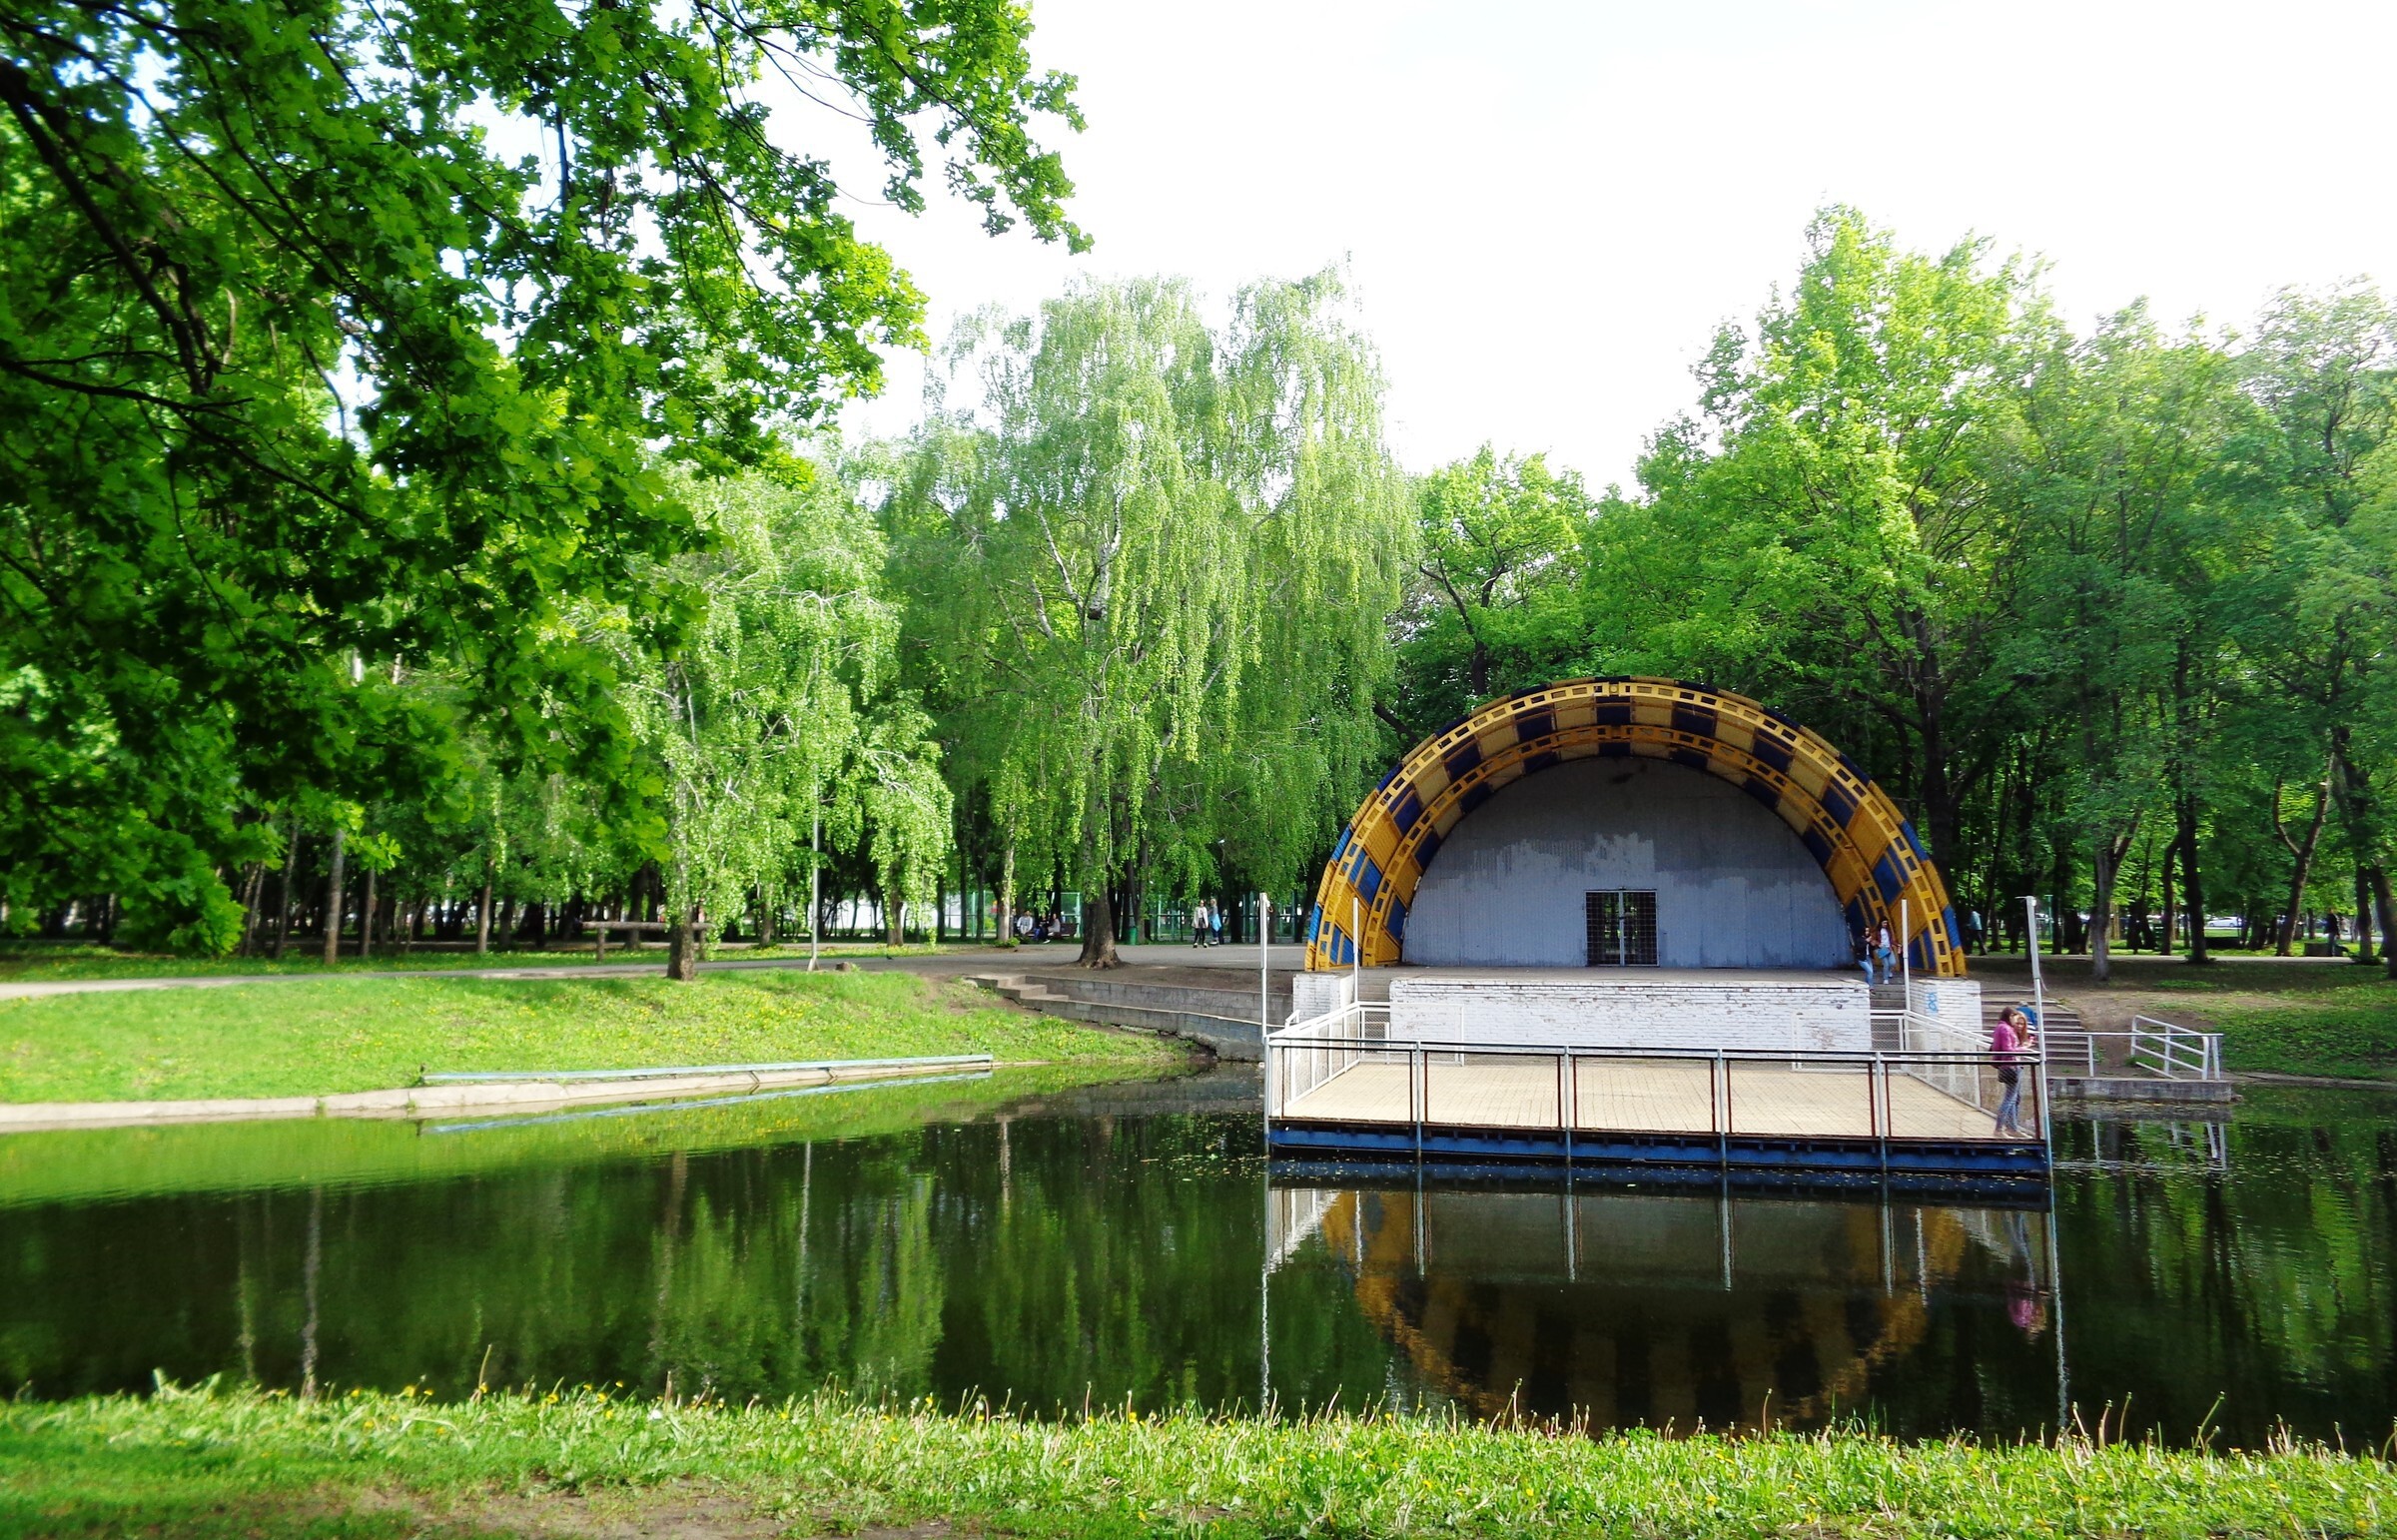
1265, 1185, 2063, 1430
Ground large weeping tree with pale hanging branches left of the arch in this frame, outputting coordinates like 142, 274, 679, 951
885, 274, 1409, 967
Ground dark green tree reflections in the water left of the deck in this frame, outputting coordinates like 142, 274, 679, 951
0, 1103, 1258, 1405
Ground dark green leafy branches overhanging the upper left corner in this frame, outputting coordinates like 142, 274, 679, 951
0, 0, 1084, 935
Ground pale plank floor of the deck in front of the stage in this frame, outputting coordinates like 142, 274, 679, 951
1282, 1056, 2027, 1140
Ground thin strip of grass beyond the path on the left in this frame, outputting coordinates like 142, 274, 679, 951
0, 941, 1002, 984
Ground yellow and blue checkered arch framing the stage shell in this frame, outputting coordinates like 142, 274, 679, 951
1306, 679, 1964, 977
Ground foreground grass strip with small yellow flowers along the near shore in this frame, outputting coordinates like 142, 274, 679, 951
0, 1391, 2397, 1540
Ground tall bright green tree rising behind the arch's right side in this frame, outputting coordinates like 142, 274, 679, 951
1587, 209, 2054, 868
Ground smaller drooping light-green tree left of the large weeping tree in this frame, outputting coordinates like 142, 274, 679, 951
625, 465, 949, 979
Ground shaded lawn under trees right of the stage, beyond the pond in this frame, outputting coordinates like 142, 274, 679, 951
1973, 957, 2397, 1082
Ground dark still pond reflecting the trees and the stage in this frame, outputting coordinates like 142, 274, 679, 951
0, 1070, 2397, 1444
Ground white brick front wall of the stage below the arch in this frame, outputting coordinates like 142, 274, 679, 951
1390, 969, 1872, 1053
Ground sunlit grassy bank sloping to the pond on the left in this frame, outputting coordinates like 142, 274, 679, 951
0, 969, 1182, 1101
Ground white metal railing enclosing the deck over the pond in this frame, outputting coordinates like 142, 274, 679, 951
1265, 1005, 2047, 1142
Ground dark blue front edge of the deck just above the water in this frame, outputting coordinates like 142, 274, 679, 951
1268, 1123, 2047, 1182
